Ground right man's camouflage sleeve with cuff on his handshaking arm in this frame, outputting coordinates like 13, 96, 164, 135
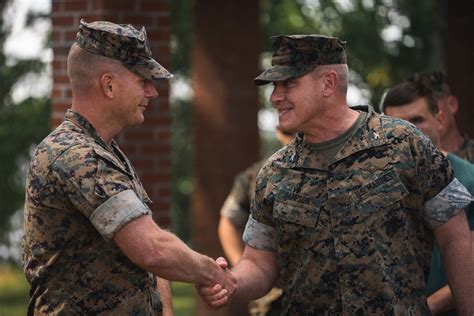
243, 164, 277, 251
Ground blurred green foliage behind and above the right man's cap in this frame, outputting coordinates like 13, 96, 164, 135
262, 0, 446, 104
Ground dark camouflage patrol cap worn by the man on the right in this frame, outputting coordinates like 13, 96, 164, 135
254, 35, 346, 86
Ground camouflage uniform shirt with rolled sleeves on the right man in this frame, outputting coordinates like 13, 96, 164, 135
244, 107, 471, 315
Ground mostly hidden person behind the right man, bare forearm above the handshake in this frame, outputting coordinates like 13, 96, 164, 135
218, 127, 294, 316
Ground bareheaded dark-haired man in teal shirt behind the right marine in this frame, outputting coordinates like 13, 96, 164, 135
382, 80, 474, 315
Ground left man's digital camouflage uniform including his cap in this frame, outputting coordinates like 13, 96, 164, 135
22, 21, 171, 315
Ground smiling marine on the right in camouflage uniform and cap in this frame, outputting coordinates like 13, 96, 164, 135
200, 35, 473, 315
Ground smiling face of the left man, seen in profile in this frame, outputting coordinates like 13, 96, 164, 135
112, 70, 158, 127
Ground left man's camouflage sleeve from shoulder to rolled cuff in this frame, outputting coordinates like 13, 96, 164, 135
53, 145, 151, 240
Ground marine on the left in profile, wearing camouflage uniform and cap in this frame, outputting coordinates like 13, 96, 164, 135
22, 21, 237, 315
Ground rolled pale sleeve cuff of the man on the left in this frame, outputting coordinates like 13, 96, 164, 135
90, 190, 151, 240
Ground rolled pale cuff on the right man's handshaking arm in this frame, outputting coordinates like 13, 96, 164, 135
243, 216, 277, 251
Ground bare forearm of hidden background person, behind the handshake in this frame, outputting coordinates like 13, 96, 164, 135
218, 217, 244, 266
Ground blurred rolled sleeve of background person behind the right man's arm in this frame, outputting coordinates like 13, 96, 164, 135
221, 171, 255, 227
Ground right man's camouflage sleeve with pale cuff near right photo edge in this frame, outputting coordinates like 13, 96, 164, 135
414, 130, 471, 229
